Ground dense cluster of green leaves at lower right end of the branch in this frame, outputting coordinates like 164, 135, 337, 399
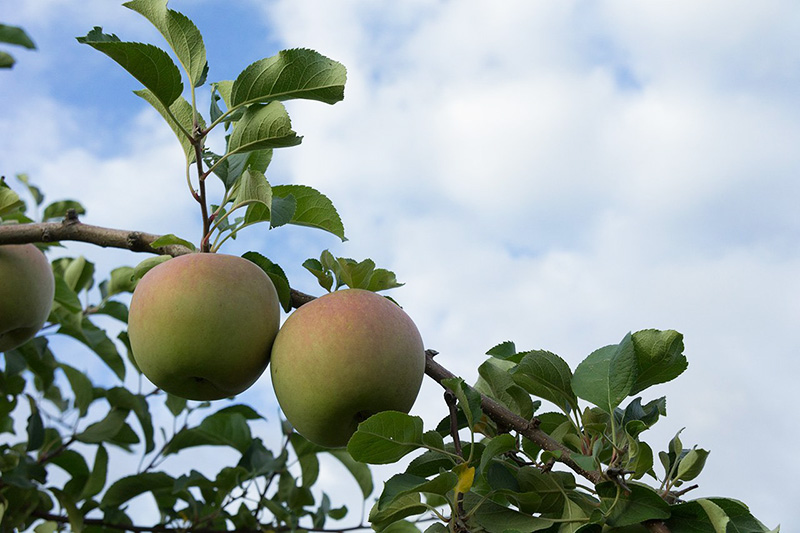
348, 330, 767, 533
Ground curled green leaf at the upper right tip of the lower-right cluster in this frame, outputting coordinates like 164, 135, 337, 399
630, 329, 689, 395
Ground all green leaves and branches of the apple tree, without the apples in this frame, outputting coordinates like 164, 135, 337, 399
0, 4, 768, 533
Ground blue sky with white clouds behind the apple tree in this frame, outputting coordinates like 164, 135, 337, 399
0, 0, 800, 527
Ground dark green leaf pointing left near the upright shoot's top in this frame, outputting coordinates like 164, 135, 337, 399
77, 26, 183, 107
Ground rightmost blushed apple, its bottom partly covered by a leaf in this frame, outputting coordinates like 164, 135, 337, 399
270, 289, 425, 447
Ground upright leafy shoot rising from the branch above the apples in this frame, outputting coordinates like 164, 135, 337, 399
78, 0, 347, 251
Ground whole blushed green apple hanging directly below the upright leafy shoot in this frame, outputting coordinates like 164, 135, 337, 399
128, 253, 280, 400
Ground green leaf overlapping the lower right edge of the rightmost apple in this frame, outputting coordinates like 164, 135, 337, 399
347, 411, 422, 464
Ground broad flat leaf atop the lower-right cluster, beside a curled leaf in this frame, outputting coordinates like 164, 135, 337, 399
572, 333, 636, 413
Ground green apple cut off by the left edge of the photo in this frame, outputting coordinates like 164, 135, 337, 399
0, 244, 56, 352
